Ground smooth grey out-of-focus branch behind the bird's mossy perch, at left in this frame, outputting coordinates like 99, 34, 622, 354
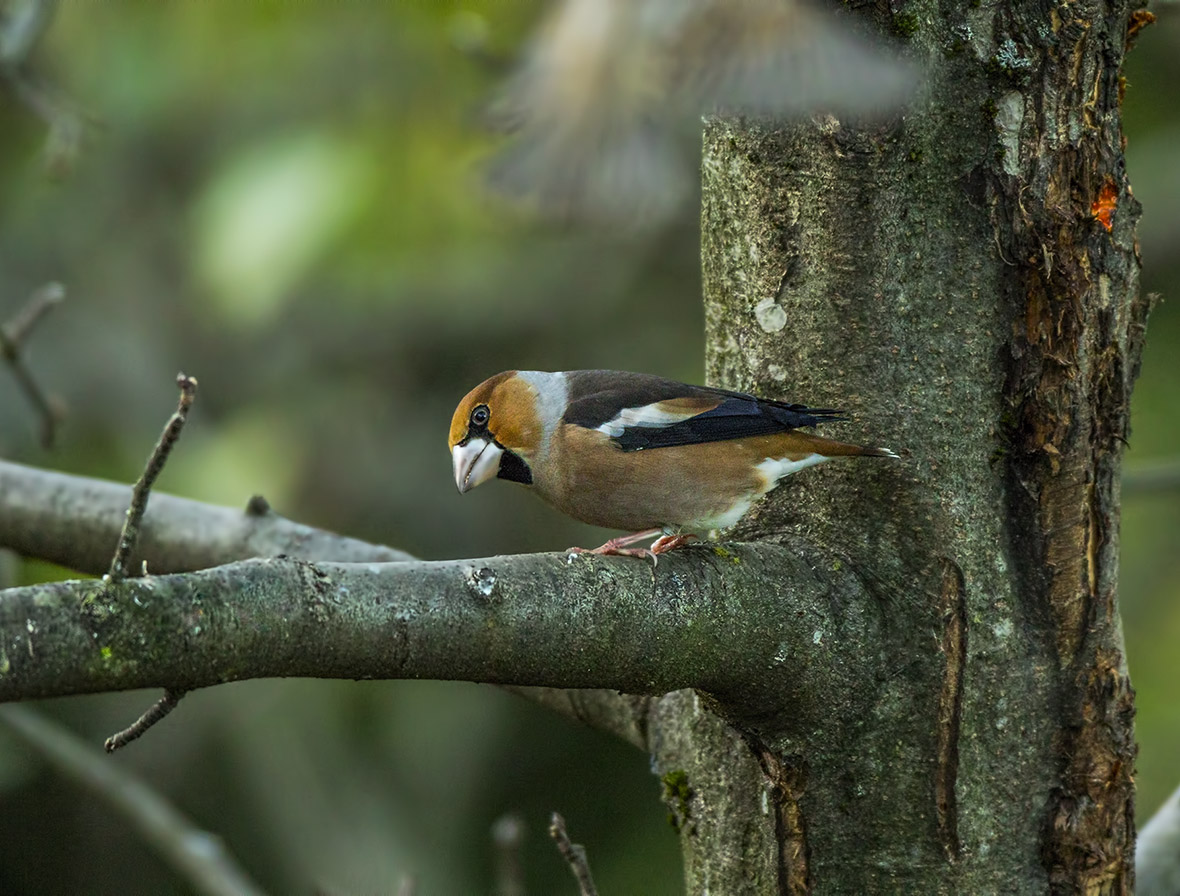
0, 460, 413, 575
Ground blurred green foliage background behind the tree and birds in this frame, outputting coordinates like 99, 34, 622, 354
0, 0, 1180, 894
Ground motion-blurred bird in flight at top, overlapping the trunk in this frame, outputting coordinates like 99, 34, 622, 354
489, 0, 918, 225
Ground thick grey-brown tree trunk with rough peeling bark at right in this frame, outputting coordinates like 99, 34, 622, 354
649, 2, 1147, 894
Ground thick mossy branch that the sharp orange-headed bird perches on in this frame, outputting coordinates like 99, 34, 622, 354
0, 543, 880, 731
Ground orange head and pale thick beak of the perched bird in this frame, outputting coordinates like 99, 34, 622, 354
448, 371, 543, 492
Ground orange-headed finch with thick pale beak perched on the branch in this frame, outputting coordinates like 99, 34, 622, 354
448, 369, 898, 562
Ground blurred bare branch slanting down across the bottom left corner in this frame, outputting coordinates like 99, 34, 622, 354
0, 704, 262, 896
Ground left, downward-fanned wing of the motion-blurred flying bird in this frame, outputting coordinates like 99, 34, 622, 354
487, 0, 690, 222
